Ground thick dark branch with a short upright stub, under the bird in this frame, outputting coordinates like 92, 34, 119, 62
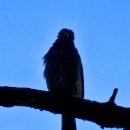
0, 86, 130, 128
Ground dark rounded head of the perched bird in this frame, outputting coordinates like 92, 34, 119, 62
58, 28, 74, 41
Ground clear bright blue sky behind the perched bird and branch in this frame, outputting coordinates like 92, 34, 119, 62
0, 0, 130, 130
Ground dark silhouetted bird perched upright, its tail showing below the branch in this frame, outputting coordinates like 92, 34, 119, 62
43, 28, 84, 130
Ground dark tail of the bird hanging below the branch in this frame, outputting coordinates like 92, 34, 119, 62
62, 115, 76, 130
